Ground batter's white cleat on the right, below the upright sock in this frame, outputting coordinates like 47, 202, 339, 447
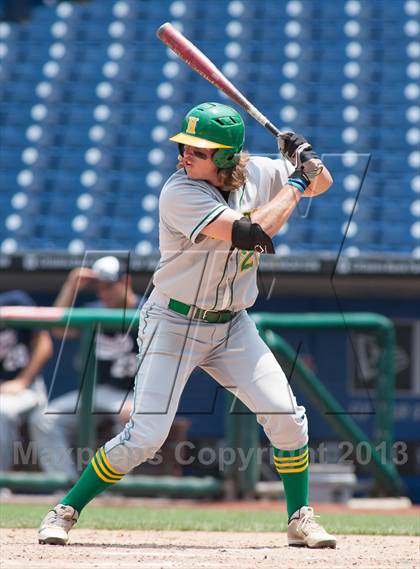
287, 506, 337, 549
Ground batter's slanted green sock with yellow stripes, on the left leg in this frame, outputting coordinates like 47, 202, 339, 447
60, 447, 125, 514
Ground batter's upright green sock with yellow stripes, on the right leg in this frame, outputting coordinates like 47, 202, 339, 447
273, 445, 309, 520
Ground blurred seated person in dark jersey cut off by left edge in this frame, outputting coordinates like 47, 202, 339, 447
0, 290, 53, 471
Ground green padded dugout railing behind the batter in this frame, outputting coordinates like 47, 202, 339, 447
0, 307, 403, 497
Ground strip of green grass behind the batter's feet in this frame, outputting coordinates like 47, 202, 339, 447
0, 504, 420, 536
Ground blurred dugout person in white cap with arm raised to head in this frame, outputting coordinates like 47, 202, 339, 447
29, 256, 140, 479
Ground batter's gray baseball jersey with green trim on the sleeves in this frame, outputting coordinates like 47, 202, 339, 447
154, 157, 294, 311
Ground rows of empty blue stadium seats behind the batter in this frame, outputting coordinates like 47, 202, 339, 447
0, 0, 418, 253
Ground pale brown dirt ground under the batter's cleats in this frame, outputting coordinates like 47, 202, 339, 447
0, 529, 420, 569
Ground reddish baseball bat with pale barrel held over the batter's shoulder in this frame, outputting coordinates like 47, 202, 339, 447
156, 22, 322, 177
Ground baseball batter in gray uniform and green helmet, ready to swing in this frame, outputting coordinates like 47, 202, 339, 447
39, 103, 336, 547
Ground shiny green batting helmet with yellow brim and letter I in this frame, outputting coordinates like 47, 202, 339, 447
169, 103, 245, 168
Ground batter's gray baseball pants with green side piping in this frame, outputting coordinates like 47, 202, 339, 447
105, 289, 308, 473
